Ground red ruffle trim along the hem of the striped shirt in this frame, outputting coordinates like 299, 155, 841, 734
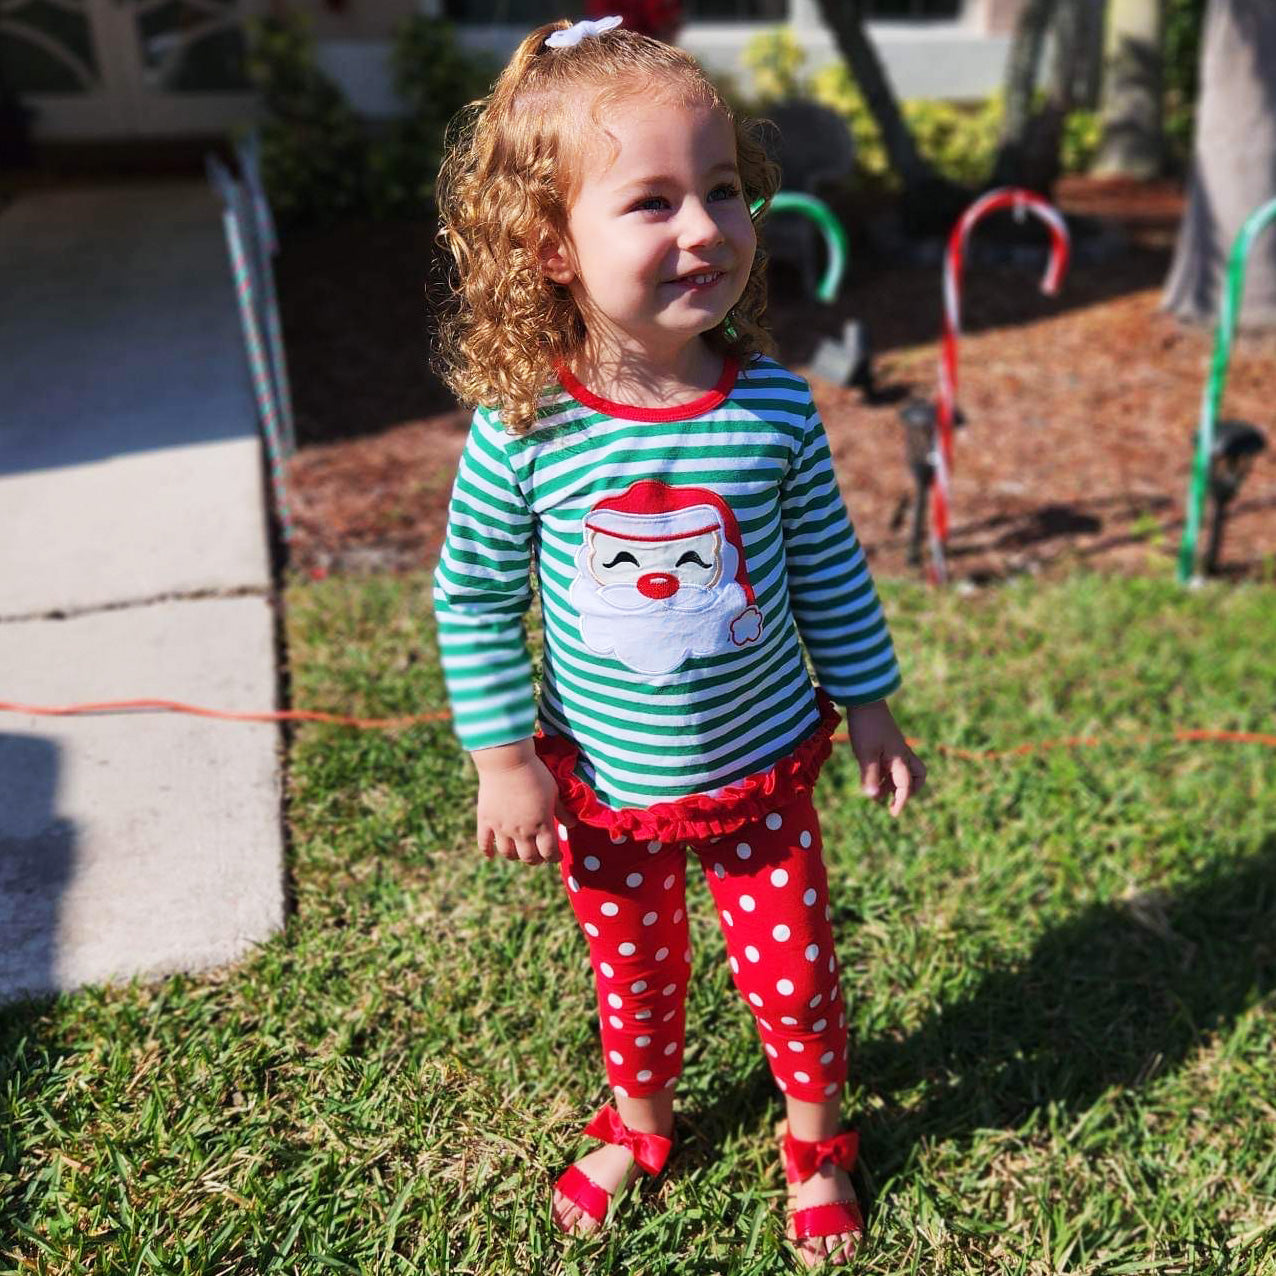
533, 688, 841, 842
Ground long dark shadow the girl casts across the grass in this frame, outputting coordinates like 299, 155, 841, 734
694, 837, 1276, 1182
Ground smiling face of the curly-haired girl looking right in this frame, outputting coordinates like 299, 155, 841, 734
542, 94, 757, 357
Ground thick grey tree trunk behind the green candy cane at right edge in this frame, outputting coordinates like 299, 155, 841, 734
1162, 0, 1276, 327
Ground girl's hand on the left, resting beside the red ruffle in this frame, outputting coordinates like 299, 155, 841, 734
472, 740, 575, 864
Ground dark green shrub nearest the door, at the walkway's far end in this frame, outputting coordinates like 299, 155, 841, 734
248, 13, 367, 226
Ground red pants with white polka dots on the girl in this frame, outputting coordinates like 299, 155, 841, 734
559, 798, 846, 1102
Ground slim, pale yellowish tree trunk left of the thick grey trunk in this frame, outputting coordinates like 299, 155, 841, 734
1094, 0, 1165, 179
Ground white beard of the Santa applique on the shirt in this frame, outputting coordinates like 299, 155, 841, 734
569, 573, 762, 674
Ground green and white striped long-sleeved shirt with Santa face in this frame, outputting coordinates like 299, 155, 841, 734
434, 357, 900, 808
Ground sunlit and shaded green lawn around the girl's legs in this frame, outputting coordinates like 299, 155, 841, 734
0, 577, 1276, 1276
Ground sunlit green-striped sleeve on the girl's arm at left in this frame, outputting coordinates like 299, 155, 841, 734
434, 408, 536, 749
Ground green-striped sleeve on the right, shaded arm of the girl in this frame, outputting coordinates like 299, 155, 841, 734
780, 402, 900, 706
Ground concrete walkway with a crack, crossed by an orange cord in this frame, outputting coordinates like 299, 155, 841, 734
0, 182, 285, 1002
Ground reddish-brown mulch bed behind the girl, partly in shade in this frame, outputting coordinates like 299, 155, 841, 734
278, 180, 1276, 582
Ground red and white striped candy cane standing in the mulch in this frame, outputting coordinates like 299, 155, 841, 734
930, 186, 1069, 582
